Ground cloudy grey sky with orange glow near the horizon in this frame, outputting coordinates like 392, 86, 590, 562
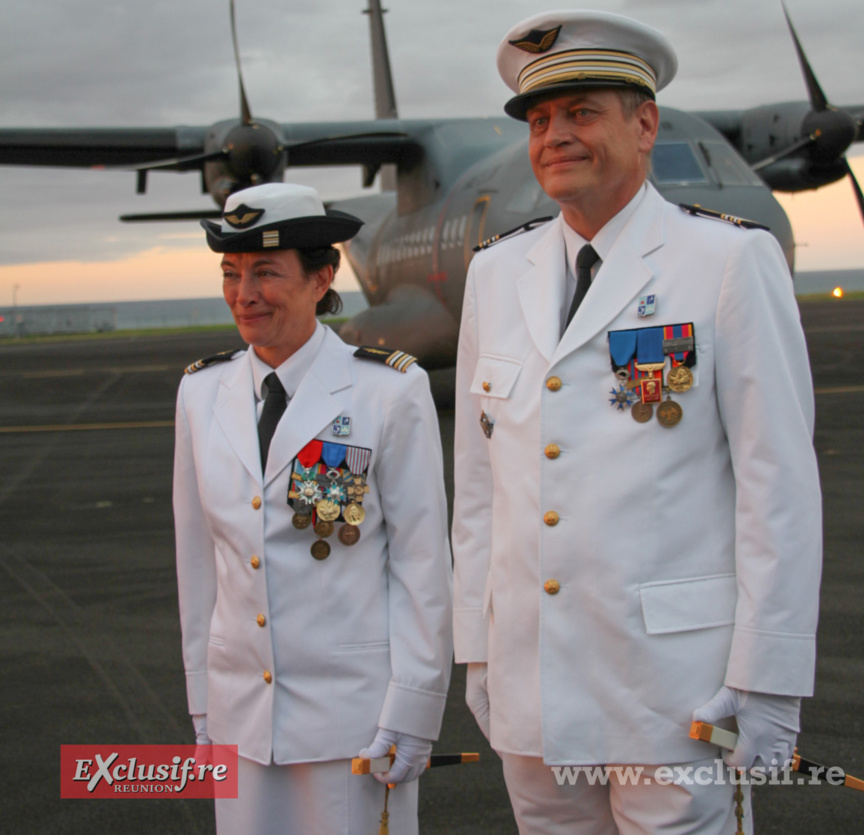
0, 0, 864, 306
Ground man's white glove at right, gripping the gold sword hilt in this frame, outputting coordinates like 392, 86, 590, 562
693, 687, 801, 769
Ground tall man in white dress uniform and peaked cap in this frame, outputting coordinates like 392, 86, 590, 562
453, 11, 821, 835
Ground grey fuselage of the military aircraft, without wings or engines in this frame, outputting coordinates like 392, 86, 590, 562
336, 108, 794, 367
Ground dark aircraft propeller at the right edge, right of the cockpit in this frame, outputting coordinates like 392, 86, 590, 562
752, 3, 864, 225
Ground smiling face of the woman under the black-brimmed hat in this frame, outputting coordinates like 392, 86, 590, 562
222, 249, 333, 368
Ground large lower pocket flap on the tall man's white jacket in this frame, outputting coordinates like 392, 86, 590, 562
639, 574, 738, 635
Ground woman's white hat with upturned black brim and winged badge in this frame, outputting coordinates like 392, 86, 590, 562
201, 183, 363, 252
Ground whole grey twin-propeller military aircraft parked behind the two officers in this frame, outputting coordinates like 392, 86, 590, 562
0, 0, 864, 367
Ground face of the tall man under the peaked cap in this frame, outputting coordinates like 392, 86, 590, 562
526, 89, 657, 225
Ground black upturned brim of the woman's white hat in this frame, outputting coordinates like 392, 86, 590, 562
201, 209, 363, 252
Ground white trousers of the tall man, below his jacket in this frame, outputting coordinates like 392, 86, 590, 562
501, 754, 753, 835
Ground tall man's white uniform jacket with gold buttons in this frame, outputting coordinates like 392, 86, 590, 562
452, 185, 821, 763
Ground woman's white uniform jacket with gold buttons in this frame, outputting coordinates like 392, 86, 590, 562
174, 329, 460, 764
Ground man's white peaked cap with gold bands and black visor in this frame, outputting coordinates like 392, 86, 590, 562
498, 10, 678, 121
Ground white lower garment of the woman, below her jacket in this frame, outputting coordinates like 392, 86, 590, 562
216, 757, 418, 835
